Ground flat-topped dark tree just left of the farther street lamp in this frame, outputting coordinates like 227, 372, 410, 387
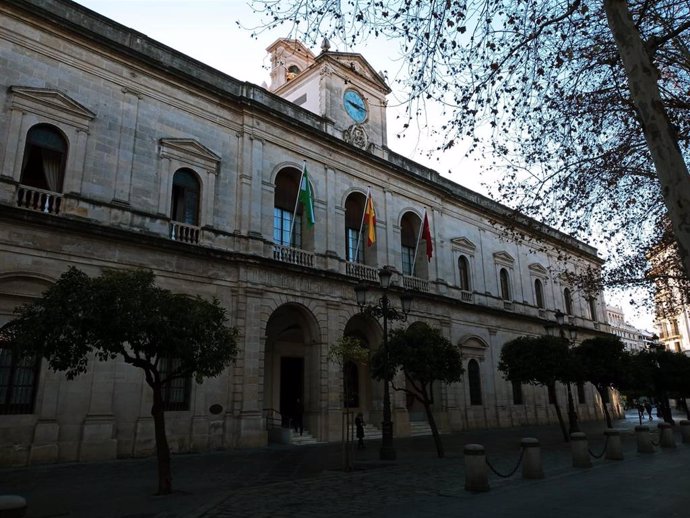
498, 336, 578, 442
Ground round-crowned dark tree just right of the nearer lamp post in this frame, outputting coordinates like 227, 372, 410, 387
371, 322, 464, 458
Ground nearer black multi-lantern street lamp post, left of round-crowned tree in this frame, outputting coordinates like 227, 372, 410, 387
355, 267, 412, 460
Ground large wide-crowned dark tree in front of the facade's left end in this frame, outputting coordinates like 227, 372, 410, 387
3, 267, 237, 494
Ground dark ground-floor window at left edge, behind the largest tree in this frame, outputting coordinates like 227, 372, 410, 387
0, 348, 40, 414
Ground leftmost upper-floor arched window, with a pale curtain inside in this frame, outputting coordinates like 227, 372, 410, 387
20, 124, 67, 192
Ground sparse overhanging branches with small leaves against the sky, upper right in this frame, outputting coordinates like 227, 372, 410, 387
247, 0, 690, 306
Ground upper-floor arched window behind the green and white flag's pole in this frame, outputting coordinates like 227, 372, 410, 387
273, 169, 302, 248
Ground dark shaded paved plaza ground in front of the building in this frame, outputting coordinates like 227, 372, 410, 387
0, 413, 690, 518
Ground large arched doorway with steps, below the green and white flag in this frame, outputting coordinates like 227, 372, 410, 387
264, 304, 320, 432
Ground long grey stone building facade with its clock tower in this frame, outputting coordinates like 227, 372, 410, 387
0, 0, 606, 465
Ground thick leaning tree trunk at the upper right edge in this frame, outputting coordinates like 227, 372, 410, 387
604, 0, 690, 276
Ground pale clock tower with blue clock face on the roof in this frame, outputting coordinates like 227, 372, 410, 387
266, 38, 391, 154
